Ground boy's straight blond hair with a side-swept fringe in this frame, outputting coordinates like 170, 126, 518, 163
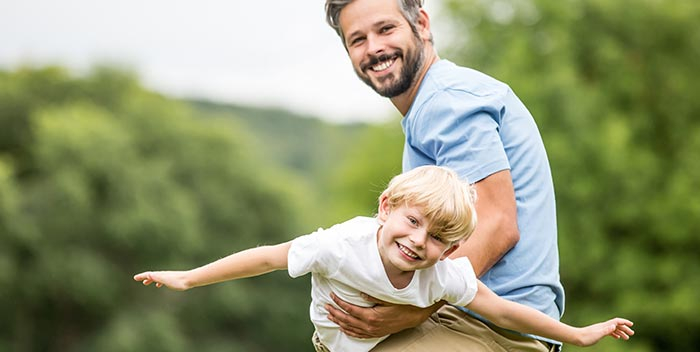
379, 165, 476, 242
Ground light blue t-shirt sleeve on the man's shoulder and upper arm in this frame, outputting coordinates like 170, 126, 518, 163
412, 91, 510, 182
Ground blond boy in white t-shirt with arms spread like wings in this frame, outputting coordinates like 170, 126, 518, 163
134, 166, 634, 351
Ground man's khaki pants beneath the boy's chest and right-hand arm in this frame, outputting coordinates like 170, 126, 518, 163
372, 306, 556, 352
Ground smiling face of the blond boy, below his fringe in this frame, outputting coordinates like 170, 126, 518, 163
377, 198, 459, 275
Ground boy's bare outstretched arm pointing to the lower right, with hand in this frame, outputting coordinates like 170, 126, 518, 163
467, 281, 634, 346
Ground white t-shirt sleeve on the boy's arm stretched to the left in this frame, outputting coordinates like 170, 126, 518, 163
287, 225, 343, 278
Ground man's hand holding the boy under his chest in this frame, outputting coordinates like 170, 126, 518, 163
326, 293, 445, 339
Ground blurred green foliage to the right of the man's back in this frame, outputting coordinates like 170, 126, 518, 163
437, 0, 700, 351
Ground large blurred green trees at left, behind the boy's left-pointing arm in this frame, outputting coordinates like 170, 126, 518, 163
0, 68, 311, 351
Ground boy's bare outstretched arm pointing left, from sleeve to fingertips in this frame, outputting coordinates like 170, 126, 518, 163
134, 242, 291, 291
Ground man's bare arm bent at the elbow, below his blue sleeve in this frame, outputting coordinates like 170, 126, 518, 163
450, 170, 520, 277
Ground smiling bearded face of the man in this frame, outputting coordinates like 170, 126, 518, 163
339, 0, 425, 98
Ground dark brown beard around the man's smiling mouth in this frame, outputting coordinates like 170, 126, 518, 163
355, 40, 425, 98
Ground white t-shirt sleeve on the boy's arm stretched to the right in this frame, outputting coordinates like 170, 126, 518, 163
444, 257, 477, 306
